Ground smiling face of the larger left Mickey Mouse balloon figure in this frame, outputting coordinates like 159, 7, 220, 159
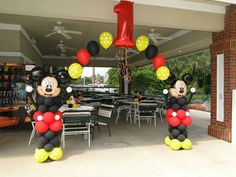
37, 76, 61, 97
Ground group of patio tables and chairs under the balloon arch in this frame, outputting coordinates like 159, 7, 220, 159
28, 93, 166, 148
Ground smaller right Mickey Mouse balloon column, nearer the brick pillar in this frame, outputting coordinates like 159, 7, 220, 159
163, 73, 196, 150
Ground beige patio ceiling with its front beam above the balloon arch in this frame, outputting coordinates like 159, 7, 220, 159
0, 0, 228, 66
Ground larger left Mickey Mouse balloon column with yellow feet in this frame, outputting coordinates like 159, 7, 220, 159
26, 67, 72, 163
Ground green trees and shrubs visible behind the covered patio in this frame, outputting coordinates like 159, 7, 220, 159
107, 51, 211, 95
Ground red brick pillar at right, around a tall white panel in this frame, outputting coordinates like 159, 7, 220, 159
208, 5, 236, 142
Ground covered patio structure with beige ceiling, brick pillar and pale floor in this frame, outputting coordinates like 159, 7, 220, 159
0, 0, 236, 177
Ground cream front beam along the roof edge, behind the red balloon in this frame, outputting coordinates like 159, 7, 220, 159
0, 0, 224, 32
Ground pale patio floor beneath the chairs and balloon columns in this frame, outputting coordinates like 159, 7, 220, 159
0, 111, 236, 177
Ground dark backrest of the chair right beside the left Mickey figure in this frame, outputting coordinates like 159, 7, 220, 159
62, 112, 91, 123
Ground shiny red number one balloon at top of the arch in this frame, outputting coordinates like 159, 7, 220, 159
114, 1, 134, 47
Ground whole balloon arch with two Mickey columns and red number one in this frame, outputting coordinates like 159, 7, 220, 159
26, 1, 195, 162
